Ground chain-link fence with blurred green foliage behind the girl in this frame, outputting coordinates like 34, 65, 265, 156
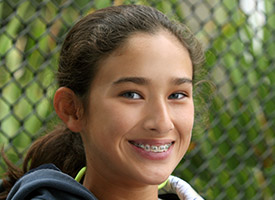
0, 0, 275, 200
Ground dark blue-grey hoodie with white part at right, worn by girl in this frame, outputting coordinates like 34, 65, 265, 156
7, 164, 203, 200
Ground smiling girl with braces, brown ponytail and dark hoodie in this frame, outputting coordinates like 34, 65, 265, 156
2, 5, 204, 200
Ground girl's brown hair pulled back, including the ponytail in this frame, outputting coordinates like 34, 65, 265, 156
0, 5, 204, 199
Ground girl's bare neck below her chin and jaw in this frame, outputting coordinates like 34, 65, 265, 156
83, 166, 158, 200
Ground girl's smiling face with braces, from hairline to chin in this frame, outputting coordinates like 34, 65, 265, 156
82, 31, 194, 188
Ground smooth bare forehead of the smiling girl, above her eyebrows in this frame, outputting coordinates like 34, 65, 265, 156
91, 31, 193, 86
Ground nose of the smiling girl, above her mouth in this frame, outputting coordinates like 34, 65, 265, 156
143, 102, 174, 134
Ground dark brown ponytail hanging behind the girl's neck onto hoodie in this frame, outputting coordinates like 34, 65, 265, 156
0, 125, 86, 200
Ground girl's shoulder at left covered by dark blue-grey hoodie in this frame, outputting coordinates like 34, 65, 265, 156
7, 164, 96, 200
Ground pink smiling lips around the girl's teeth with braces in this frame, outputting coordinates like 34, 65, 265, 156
128, 139, 175, 160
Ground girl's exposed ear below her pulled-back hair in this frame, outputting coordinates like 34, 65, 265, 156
53, 87, 82, 132
